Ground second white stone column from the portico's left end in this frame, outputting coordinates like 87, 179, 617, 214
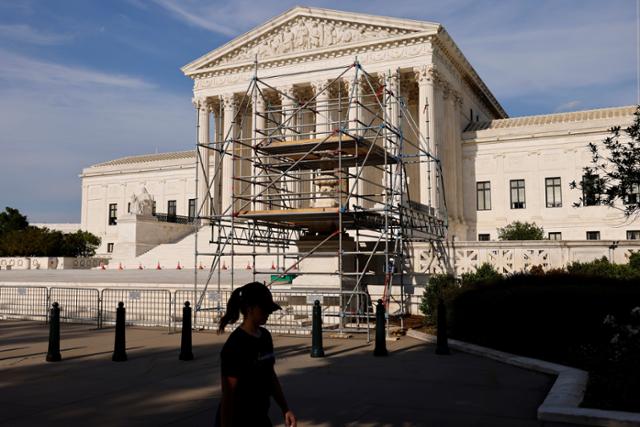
220, 94, 238, 215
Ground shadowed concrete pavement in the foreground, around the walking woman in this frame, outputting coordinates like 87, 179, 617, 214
0, 320, 553, 426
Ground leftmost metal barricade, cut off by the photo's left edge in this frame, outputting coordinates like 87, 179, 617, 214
0, 286, 49, 321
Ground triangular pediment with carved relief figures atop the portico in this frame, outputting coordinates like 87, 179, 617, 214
182, 7, 441, 75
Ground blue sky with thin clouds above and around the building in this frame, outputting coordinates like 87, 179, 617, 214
0, 0, 637, 223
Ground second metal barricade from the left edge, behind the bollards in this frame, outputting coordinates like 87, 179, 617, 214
49, 287, 100, 326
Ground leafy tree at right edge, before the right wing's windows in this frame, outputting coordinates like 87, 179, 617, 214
570, 105, 640, 216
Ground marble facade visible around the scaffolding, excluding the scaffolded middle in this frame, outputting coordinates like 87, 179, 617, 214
81, 7, 640, 269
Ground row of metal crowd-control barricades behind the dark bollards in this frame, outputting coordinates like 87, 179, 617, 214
0, 286, 375, 335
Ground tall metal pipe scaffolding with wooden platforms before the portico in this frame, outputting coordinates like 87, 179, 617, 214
194, 58, 447, 328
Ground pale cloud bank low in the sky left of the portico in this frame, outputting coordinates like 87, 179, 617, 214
0, 52, 194, 222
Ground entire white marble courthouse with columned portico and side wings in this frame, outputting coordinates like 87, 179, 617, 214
81, 7, 640, 278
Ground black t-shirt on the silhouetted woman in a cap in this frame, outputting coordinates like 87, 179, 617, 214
220, 328, 275, 426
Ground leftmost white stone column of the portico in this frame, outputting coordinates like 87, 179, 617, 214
194, 98, 211, 216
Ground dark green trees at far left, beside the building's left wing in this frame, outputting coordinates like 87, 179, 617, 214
0, 207, 100, 257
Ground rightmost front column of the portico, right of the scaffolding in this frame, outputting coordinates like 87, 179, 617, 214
414, 65, 438, 209
